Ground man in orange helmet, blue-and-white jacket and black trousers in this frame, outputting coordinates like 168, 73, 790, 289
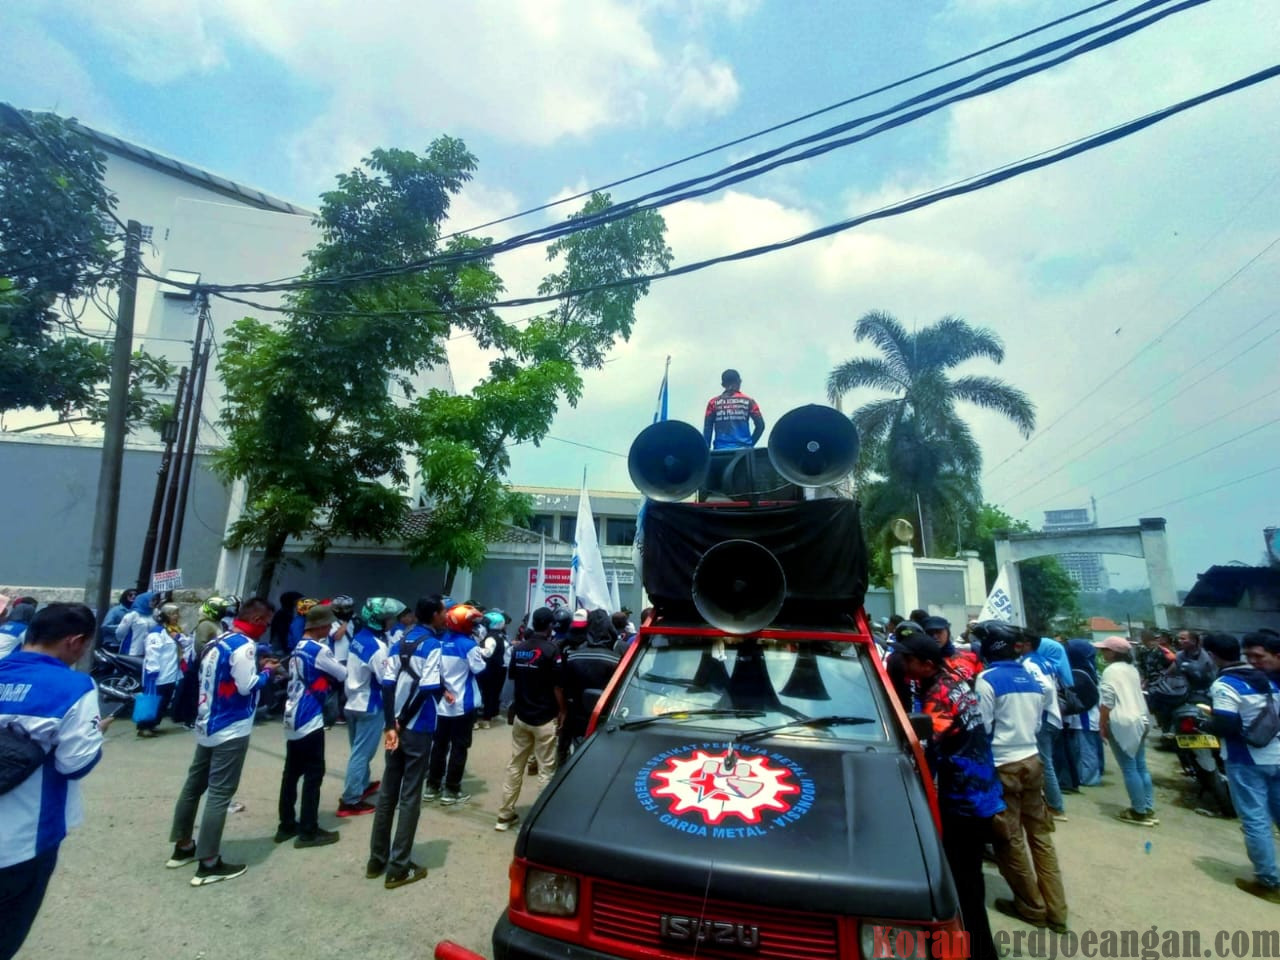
422, 603, 485, 805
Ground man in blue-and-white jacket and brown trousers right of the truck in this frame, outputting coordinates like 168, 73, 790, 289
973, 621, 1066, 933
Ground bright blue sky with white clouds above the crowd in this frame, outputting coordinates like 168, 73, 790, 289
0, 0, 1280, 589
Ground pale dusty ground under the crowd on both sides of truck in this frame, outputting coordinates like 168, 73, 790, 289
20, 722, 1280, 960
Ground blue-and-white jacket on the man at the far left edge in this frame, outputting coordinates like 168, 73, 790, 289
0, 650, 102, 868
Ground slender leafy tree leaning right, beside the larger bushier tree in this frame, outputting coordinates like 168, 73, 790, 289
410, 193, 671, 590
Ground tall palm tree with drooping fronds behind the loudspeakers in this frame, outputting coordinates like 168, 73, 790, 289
827, 310, 1036, 553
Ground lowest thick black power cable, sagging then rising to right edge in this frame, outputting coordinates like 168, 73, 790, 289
202, 65, 1280, 337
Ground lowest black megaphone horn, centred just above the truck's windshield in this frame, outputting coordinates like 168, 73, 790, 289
692, 540, 787, 634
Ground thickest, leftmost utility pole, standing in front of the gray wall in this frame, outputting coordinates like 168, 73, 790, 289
76, 220, 142, 671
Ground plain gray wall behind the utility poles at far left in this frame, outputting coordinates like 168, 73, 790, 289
0, 442, 228, 590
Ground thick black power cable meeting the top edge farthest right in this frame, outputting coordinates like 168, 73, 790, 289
150, 0, 1208, 293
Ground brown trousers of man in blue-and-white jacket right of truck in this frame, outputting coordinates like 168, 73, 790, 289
991, 756, 1066, 924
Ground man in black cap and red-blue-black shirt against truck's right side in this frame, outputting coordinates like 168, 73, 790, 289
895, 630, 1005, 960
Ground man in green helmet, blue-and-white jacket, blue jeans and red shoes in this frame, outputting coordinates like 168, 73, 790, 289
338, 596, 404, 817
